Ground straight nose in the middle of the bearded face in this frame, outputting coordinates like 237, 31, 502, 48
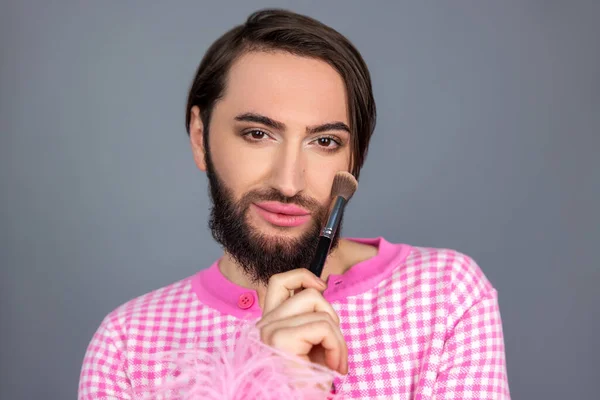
270, 141, 306, 197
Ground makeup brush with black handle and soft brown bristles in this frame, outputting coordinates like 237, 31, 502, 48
309, 171, 358, 278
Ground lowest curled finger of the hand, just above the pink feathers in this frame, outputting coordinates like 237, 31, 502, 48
266, 320, 347, 374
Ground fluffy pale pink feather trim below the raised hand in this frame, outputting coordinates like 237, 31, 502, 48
132, 323, 344, 400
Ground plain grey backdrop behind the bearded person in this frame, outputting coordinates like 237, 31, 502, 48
0, 0, 600, 399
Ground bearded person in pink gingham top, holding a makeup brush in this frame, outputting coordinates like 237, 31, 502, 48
79, 9, 510, 399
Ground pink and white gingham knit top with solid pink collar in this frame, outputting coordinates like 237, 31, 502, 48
79, 238, 510, 400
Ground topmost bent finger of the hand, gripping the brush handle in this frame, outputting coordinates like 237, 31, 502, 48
263, 268, 327, 315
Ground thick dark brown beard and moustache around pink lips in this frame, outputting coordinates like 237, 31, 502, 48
205, 149, 341, 285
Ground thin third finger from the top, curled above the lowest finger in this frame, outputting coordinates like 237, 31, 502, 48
260, 312, 348, 374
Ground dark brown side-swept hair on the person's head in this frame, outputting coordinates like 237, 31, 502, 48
185, 9, 376, 179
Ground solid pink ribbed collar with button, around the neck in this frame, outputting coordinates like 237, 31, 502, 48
192, 237, 411, 319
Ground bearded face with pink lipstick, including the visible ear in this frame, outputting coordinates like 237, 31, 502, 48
192, 52, 350, 283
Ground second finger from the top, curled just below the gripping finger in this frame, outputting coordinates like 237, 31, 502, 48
256, 288, 340, 328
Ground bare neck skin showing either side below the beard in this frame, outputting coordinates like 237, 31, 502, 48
219, 239, 377, 308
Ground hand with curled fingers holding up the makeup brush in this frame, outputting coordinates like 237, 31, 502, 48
256, 268, 348, 375
